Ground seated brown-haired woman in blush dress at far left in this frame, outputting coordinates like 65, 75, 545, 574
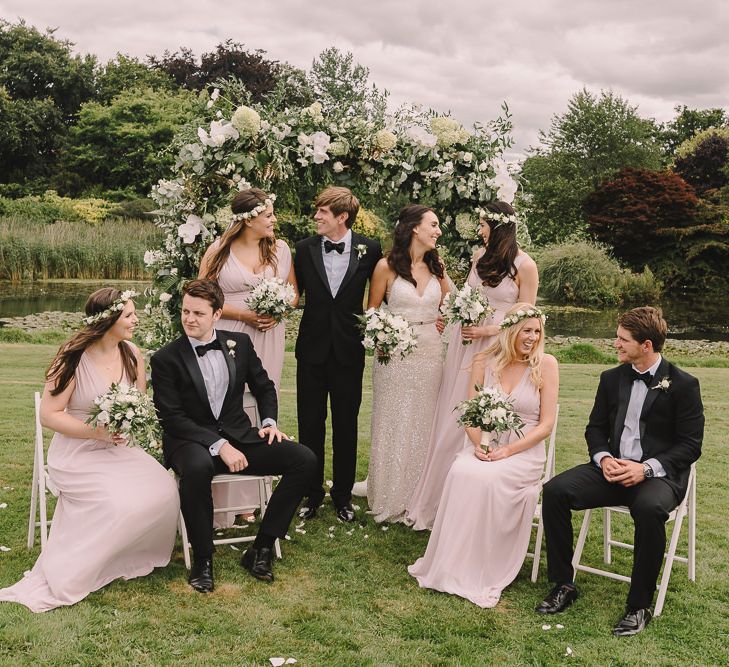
0, 288, 179, 612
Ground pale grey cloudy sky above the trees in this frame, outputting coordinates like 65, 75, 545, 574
0, 0, 729, 150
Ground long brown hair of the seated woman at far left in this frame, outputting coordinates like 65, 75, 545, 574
46, 287, 137, 396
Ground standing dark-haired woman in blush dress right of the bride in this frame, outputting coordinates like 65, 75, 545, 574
405, 201, 539, 530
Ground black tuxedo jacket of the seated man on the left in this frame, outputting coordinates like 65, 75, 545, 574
150, 331, 278, 461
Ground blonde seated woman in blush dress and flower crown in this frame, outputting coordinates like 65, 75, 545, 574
408, 303, 559, 607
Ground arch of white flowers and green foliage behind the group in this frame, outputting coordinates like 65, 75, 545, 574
144, 83, 517, 348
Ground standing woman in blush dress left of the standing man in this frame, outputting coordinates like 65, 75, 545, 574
199, 188, 299, 528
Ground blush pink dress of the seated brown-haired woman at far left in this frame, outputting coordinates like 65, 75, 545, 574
0, 353, 180, 612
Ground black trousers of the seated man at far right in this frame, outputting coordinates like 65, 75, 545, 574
542, 463, 681, 609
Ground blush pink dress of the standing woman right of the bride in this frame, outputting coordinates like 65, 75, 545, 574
405, 252, 529, 530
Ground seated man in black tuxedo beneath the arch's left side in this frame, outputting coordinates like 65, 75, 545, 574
151, 280, 316, 593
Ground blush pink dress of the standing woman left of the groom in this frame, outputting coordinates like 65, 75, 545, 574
213, 239, 292, 528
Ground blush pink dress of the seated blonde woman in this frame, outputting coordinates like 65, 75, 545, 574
408, 368, 545, 607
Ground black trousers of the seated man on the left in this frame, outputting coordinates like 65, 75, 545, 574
170, 440, 316, 559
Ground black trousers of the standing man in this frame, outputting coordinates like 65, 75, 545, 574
296, 358, 364, 507
